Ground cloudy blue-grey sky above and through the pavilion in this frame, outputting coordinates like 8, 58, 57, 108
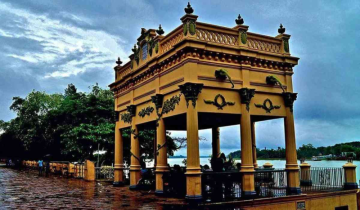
0, 0, 360, 155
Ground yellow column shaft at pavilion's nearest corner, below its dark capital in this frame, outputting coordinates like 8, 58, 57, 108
186, 99, 202, 200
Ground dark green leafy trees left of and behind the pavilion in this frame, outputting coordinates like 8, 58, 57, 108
0, 84, 184, 162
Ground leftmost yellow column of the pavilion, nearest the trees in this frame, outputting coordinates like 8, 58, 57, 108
113, 122, 124, 186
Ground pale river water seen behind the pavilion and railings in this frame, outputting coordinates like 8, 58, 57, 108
168, 158, 360, 182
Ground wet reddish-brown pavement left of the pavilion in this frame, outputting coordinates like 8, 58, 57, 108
0, 166, 181, 209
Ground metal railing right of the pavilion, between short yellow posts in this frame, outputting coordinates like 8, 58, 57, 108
300, 167, 345, 192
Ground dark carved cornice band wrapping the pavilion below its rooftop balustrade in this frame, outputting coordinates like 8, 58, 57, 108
110, 48, 295, 95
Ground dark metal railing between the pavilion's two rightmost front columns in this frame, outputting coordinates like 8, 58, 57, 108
254, 169, 287, 197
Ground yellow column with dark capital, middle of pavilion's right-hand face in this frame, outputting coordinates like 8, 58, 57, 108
240, 88, 256, 198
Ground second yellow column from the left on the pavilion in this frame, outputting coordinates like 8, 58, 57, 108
129, 124, 141, 189
